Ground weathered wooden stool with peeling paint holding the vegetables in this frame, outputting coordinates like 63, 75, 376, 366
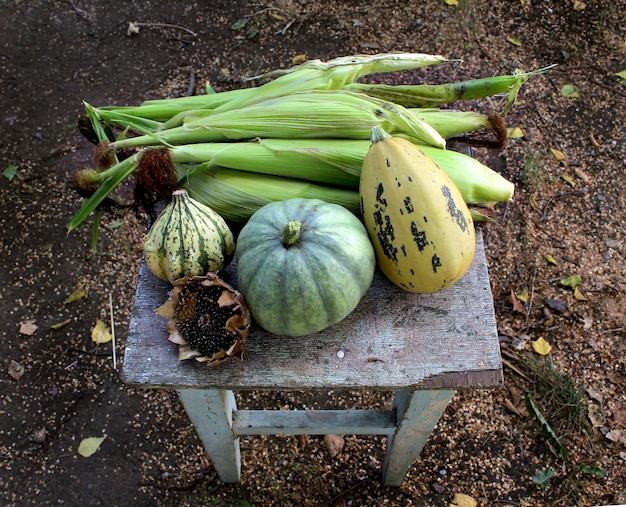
122, 228, 503, 486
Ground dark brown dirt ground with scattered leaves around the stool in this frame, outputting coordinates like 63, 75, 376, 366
0, 0, 626, 507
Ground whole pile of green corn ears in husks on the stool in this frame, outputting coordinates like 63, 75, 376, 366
69, 53, 547, 230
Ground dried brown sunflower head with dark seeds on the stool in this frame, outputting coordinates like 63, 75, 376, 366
156, 273, 250, 366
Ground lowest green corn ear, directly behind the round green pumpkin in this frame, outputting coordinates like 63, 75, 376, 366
178, 167, 360, 222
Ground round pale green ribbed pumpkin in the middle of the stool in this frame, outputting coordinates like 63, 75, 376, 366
236, 199, 376, 336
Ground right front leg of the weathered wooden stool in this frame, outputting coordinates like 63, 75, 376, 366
383, 389, 454, 486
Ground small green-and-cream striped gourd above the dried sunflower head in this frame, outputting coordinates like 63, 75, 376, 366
143, 190, 235, 283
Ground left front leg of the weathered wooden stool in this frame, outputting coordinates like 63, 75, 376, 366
176, 389, 241, 482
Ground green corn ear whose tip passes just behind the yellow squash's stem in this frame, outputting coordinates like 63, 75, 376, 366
110, 90, 445, 150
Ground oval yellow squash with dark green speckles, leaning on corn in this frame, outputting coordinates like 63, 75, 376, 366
359, 128, 476, 293
